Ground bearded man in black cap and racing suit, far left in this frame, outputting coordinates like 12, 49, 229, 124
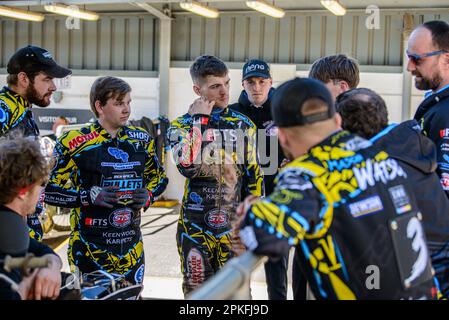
0, 45, 72, 240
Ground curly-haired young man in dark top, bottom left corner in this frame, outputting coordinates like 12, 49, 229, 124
0, 138, 62, 300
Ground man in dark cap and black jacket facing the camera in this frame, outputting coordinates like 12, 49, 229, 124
229, 59, 288, 300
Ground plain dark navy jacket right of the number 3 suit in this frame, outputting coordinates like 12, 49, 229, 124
370, 120, 449, 298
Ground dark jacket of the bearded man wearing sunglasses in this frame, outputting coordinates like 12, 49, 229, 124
414, 88, 449, 197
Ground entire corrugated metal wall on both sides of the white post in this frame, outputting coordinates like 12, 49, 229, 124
0, 12, 449, 71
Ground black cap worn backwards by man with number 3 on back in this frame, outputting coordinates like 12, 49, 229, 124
271, 78, 335, 128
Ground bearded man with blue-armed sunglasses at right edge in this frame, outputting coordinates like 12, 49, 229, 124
407, 21, 449, 196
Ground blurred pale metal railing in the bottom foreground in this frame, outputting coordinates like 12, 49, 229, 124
186, 251, 268, 300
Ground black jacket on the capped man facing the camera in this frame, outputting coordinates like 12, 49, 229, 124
229, 88, 285, 195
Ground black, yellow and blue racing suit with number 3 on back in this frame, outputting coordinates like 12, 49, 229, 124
240, 131, 438, 299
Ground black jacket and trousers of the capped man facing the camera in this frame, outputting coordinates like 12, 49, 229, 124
229, 88, 288, 300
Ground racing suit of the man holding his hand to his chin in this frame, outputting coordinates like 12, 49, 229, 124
168, 107, 264, 294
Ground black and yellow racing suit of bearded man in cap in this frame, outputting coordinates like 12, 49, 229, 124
0, 87, 44, 241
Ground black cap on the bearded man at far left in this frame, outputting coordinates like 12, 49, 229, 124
6, 46, 72, 78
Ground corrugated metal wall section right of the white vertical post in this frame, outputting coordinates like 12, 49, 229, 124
171, 13, 449, 66
